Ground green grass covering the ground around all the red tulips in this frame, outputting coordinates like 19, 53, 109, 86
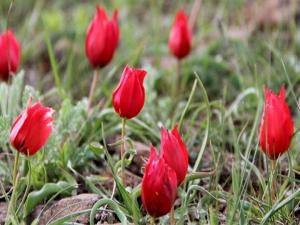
0, 0, 300, 224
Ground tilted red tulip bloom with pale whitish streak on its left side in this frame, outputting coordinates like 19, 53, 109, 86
10, 99, 54, 156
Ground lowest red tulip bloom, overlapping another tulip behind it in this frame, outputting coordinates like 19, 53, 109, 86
142, 145, 177, 217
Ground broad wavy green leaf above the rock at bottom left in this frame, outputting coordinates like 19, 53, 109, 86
24, 181, 75, 217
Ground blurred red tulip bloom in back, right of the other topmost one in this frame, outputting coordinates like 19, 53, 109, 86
169, 9, 192, 59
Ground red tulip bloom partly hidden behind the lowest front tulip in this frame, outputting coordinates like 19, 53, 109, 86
160, 126, 188, 185
